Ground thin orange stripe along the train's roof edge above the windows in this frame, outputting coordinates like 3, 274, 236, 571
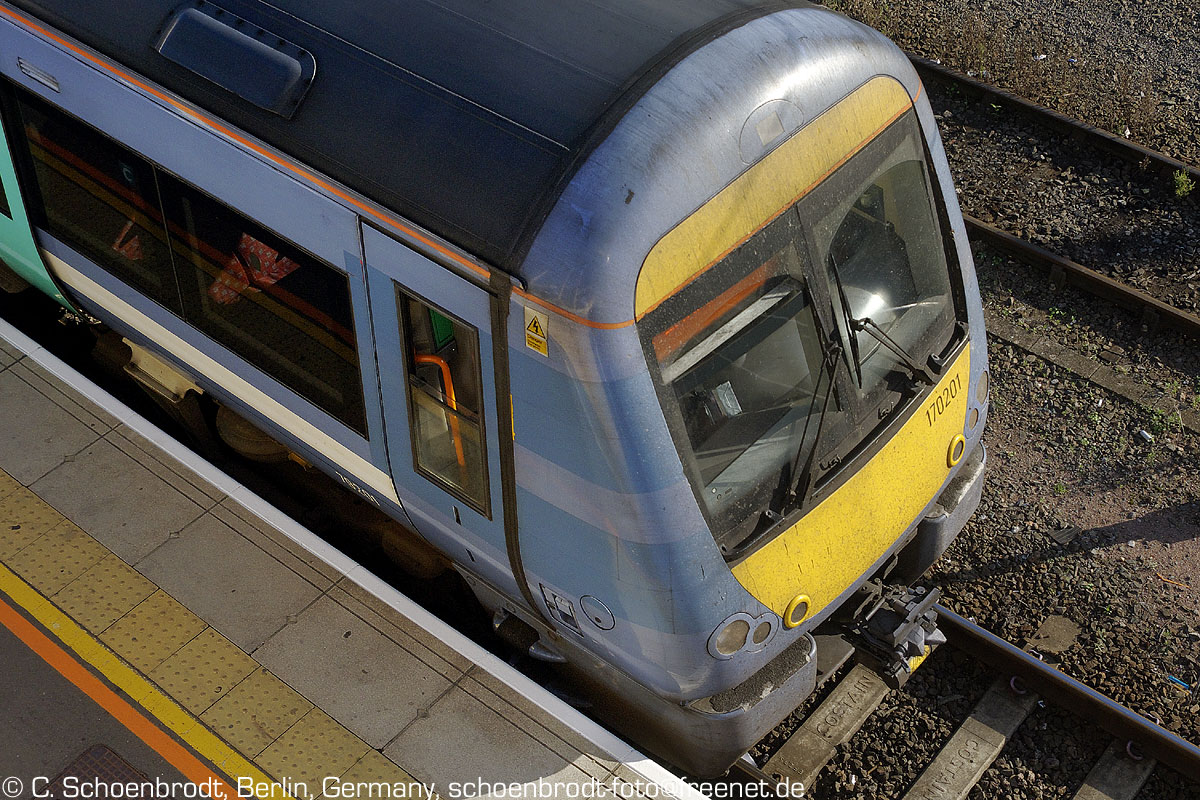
0, 6, 648, 330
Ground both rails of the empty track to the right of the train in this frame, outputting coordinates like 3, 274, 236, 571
910, 55, 1200, 337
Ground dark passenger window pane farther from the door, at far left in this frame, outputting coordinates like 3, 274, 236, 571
19, 92, 180, 313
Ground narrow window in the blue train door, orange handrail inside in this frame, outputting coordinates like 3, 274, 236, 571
396, 289, 488, 515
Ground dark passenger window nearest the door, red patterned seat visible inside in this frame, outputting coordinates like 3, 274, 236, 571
160, 173, 367, 435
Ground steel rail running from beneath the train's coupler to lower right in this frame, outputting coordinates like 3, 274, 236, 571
936, 606, 1200, 782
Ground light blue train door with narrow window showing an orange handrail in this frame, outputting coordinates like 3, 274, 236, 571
362, 225, 512, 584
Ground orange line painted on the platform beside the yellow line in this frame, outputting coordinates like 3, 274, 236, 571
0, 600, 238, 800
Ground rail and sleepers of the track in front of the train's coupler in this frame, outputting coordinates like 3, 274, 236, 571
734, 606, 1200, 800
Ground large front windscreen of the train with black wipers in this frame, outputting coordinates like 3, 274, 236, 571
640, 112, 955, 553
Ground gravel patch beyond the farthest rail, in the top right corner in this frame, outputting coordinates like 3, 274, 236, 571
824, 0, 1200, 166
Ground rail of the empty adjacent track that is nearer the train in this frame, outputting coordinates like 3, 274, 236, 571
962, 215, 1200, 337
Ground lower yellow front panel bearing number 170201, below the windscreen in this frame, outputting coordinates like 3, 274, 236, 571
733, 348, 971, 616
